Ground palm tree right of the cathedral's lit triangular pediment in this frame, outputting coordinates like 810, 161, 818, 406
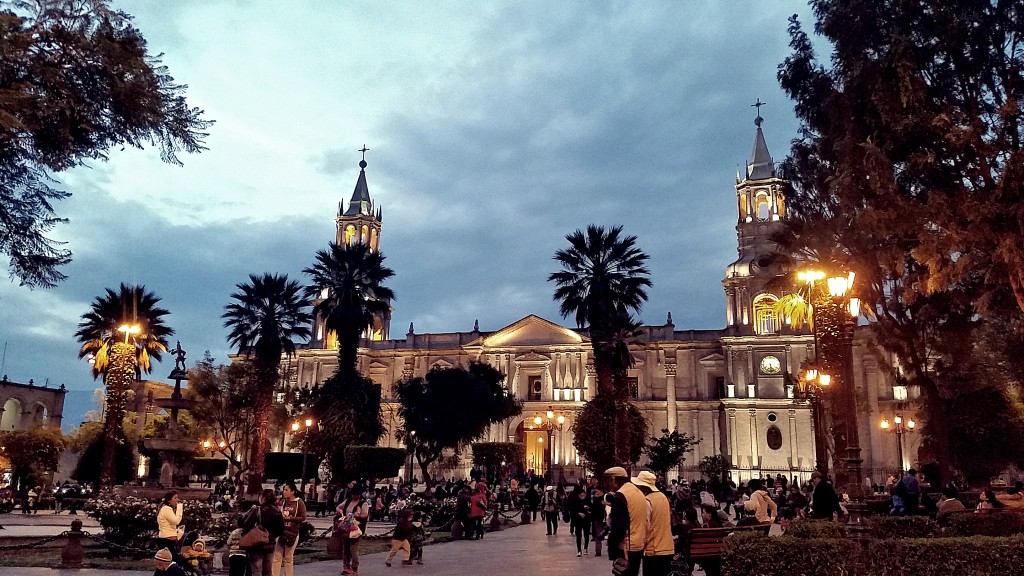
548, 224, 651, 463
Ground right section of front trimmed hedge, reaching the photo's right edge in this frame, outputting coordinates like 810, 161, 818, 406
864, 532, 1024, 576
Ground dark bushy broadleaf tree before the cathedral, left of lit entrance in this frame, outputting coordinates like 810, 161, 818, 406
395, 362, 522, 480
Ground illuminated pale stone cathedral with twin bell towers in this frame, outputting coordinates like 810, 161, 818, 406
286, 117, 916, 482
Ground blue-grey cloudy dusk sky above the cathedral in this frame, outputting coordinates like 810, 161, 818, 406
0, 0, 810, 419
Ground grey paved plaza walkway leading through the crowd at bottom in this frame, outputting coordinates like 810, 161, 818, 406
0, 516, 701, 576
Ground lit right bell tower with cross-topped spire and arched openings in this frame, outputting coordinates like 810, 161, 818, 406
722, 105, 786, 335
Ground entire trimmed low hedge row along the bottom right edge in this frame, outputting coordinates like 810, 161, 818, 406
722, 534, 1024, 576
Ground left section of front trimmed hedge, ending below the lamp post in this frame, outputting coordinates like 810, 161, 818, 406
722, 533, 860, 576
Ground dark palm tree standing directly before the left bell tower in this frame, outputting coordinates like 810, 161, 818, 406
303, 242, 394, 373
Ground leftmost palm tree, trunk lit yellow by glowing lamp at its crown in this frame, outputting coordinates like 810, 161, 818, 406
75, 283, 174, 488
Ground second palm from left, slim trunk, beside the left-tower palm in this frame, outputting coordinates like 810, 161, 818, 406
221, 274, 310, 494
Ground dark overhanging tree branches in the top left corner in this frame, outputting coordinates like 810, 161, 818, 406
0, 0, 211, 287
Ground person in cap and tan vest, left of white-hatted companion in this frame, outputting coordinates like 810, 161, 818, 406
604, 466, 648, 576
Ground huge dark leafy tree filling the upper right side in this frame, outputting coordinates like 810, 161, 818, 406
779, 0, 1024, 475
